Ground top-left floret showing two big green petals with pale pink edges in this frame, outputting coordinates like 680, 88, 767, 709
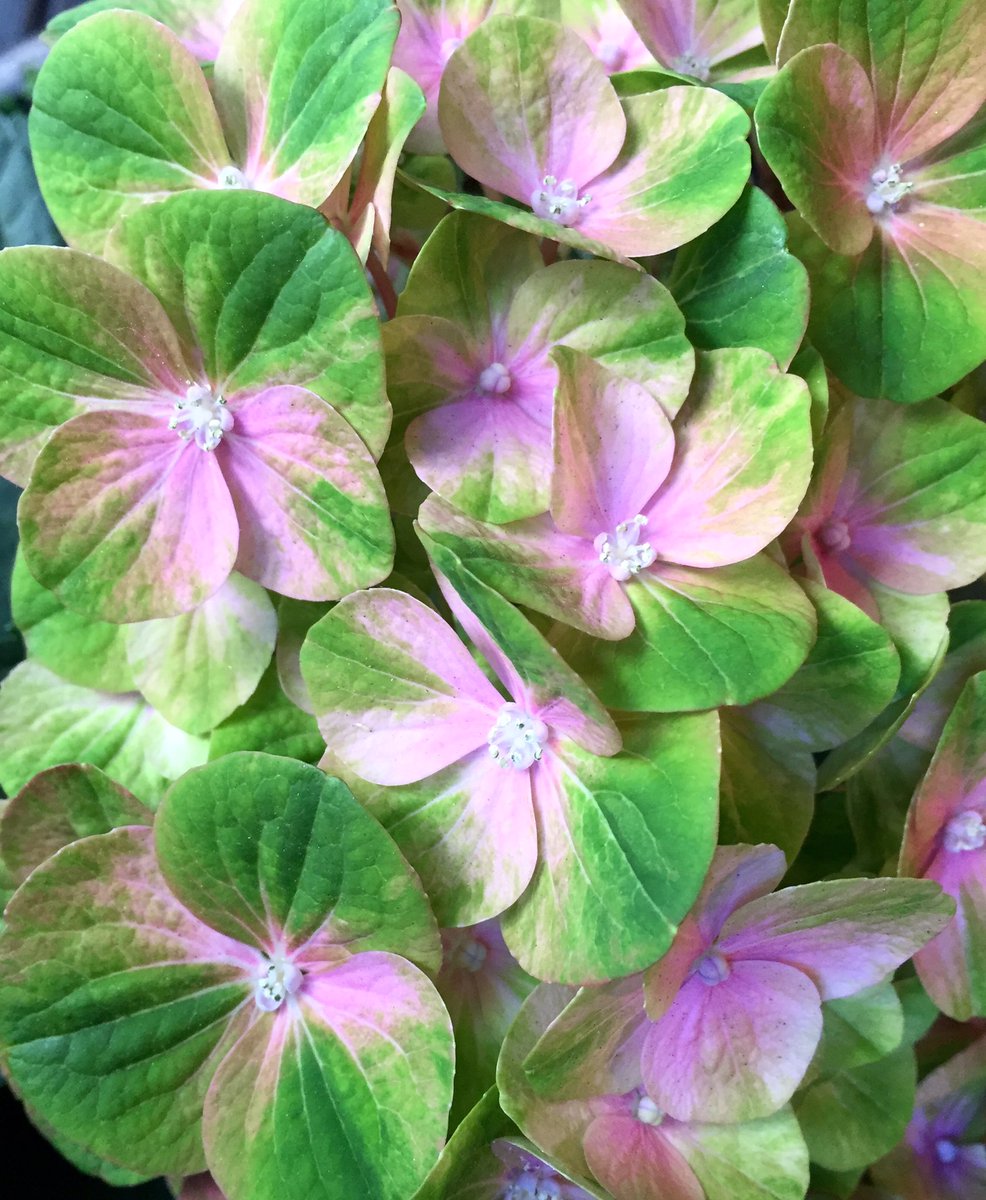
31, 0, 397, 253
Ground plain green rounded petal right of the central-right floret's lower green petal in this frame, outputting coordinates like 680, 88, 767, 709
756, 581, 901, 751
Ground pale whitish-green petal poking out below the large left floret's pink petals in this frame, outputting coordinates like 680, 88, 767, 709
126, 572, 277, 734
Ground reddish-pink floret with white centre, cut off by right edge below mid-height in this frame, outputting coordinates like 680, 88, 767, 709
901, 672, 986, 1021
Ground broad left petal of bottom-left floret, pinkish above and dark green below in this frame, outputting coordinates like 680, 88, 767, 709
0, 828, 251, 1175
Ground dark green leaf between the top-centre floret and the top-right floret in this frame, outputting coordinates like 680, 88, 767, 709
667, 187, 808, 370
